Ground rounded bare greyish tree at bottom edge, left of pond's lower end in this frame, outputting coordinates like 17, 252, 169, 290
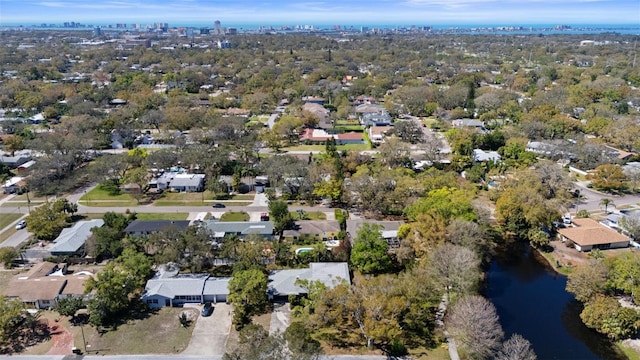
445, 295, 504, 359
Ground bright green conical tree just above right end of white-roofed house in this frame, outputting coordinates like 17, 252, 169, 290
351, 223, 393, 274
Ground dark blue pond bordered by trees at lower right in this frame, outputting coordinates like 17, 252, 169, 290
483, 241, 627, 360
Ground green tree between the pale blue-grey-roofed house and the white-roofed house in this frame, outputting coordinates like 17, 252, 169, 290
229, 269, 268, 330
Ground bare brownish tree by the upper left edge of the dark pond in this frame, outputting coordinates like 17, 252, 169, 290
429, 244, 481, 295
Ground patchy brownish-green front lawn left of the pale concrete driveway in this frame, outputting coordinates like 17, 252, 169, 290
74, 307, 197, 355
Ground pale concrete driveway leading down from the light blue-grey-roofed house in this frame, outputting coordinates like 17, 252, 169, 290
181, 303, 233, 356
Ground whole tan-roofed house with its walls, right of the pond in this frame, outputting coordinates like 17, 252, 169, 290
558, 218, 629, 251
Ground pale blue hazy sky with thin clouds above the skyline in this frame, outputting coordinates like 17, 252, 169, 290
0, 0, 640, 26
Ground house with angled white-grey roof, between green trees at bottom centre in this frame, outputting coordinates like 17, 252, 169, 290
267, 262, 351, 301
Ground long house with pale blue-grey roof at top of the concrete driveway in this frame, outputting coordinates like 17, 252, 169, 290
142, 264, 230, 308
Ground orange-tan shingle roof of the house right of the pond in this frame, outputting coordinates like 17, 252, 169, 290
558, 219, 629, 246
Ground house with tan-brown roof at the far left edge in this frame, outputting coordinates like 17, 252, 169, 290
4, 261, 93, 309
